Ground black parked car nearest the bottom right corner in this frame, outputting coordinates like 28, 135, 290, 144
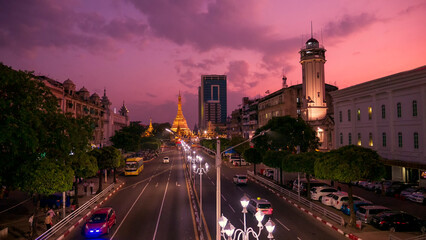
371, 211, 426, 233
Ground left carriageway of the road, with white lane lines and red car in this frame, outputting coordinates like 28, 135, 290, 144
66, 151, 196, 240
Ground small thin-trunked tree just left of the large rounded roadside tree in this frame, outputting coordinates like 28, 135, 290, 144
282, 152, 323, 199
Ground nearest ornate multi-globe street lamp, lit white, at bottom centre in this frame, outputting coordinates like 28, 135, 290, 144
219, 195, 275, 240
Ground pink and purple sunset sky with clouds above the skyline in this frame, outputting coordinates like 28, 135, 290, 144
0, 0, 426, 128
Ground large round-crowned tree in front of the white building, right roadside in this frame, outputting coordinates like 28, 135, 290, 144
315, 145, 385, 226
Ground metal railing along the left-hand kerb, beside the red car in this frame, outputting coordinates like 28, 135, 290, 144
36, 183, 115, 240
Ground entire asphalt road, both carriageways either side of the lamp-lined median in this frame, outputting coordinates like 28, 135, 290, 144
66, 147, 346, 240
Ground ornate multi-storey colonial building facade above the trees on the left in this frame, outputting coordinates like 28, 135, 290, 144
40, 76, 130, 147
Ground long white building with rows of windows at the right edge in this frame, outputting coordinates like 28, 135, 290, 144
331, 66, 426, 186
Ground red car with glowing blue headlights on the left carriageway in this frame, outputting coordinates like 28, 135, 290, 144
84, 207, 117, 237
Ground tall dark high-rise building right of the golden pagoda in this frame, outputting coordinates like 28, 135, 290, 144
198, 75, 227, 131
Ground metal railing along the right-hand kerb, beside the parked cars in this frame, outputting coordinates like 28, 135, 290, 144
247, 171, 344, 226
